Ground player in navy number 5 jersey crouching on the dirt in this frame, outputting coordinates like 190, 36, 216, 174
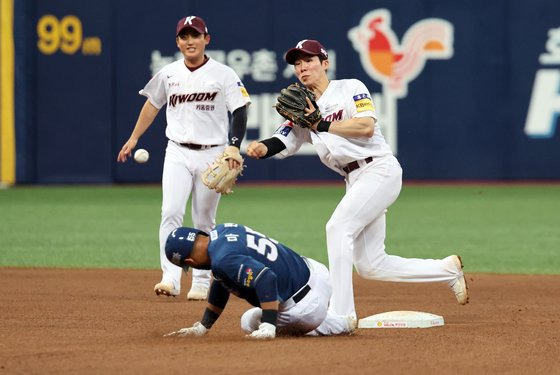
165, 223, 357, 339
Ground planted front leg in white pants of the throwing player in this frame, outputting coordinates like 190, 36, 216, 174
327, 158, 402, 315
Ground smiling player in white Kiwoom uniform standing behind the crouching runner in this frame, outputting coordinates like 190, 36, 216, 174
117, 16, 250, 300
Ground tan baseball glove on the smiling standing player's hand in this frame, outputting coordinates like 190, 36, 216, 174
202, 152, 244, 194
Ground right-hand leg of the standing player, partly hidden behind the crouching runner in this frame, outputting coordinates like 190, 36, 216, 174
187, 147, 223, 300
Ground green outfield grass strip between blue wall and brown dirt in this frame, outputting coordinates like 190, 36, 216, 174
0, 185, 560, 274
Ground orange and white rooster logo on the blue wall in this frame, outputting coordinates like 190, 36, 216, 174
348, 9, 453, 98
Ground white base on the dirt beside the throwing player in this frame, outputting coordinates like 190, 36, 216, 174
358, 311, 444, 328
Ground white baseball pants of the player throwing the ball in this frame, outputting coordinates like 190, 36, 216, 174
326, 156, 458, 316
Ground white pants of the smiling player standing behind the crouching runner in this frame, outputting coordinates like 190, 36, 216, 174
159, 141, 225, 291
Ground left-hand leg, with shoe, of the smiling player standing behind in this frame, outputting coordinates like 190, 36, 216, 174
154, 141, 192, 295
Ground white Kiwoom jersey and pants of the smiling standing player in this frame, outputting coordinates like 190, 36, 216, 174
139, 58, 251, 292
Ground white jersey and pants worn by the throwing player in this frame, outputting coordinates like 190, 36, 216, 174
274, 79, 461, 316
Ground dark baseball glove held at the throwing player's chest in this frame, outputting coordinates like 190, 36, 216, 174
275, 83, 321, 128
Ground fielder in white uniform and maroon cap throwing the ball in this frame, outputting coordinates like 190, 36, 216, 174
247, 39, 468, 315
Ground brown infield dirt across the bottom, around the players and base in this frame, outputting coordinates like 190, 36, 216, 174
0, 268, 560, 375
